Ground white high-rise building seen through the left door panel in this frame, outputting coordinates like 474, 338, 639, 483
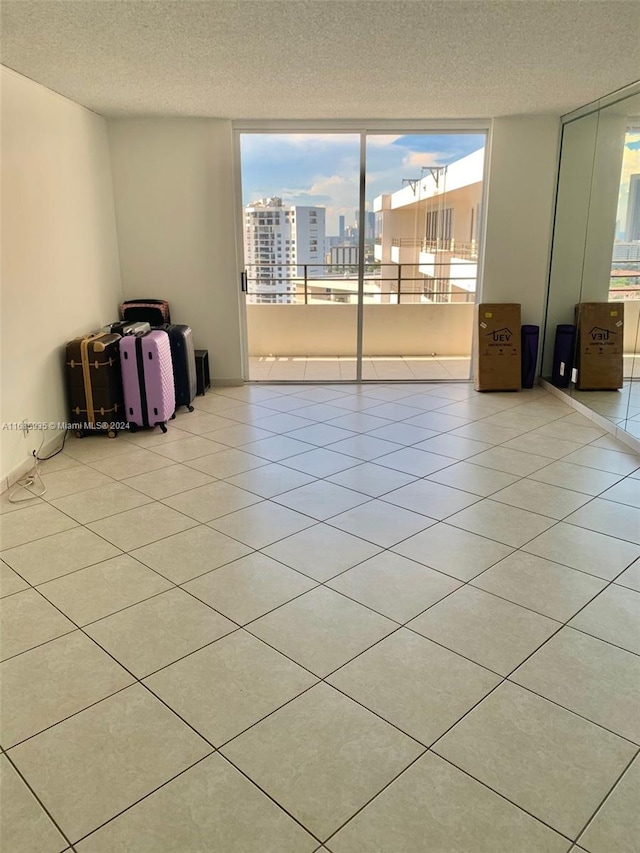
244, 196, 326, 303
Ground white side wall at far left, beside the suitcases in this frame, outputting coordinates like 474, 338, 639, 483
0, 68, 121, 479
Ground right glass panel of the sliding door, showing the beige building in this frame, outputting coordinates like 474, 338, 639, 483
362, 133, 486, 380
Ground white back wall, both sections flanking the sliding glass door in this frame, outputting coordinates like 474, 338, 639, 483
109, 116, 560, 383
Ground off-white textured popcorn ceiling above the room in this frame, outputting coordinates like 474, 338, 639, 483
0, 0, 640, 119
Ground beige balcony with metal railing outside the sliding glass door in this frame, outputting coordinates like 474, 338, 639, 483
246, 264, 474, 380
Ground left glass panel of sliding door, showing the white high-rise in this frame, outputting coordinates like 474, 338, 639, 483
240, 133, 360, 381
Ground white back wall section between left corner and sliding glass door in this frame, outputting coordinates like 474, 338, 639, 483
109, 118, 242, 383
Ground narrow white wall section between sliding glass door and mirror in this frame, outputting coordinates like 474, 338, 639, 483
482, 116, 560, 326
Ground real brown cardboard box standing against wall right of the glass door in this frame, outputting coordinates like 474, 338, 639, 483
473, 302, 521, 391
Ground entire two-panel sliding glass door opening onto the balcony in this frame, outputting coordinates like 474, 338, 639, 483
238, 129, 486, 382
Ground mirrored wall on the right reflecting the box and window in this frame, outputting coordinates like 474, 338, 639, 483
541, 84, 640, 440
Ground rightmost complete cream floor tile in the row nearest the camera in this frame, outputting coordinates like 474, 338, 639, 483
433, 682, 636, 838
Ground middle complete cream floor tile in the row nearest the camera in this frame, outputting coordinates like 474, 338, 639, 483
222, 684, 422, 839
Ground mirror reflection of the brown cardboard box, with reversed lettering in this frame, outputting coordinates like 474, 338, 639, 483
576, 302, 624, 391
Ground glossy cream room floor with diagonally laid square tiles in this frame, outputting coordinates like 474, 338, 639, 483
0, 384, 640, 853
